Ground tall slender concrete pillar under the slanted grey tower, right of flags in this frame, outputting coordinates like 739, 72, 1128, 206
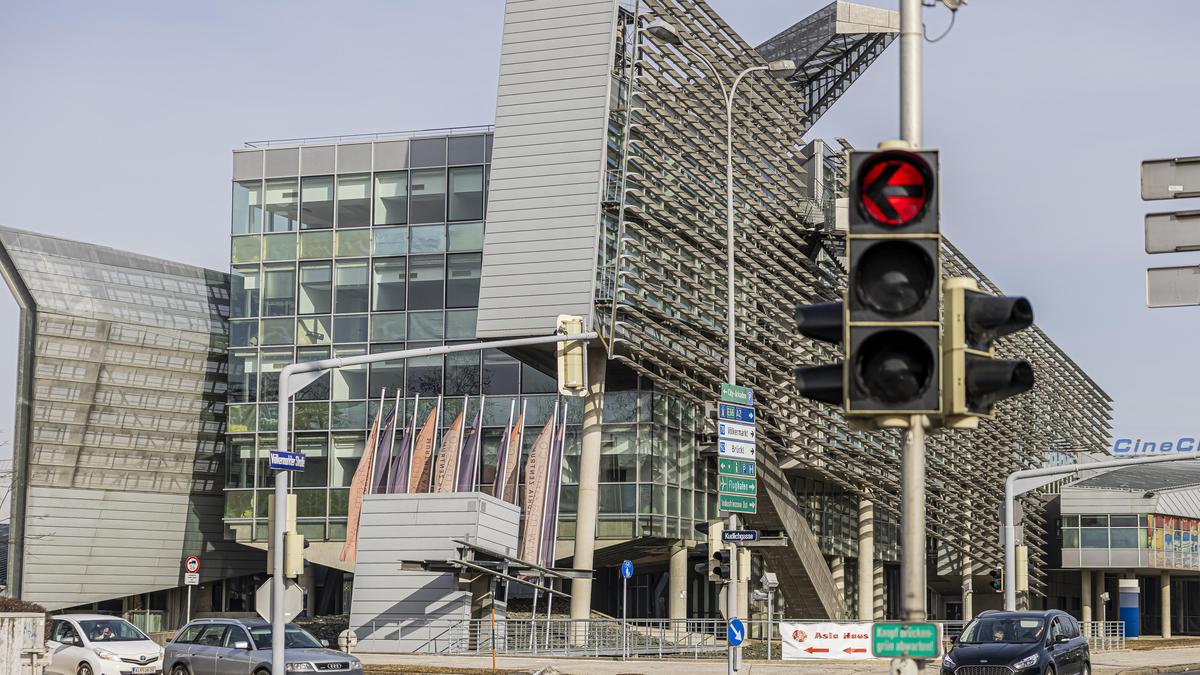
571, 355, 608, 619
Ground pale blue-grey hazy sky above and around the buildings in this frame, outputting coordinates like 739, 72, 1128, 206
0, 0, 1200, 452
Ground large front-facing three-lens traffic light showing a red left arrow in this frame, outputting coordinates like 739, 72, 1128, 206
845, 148, 942, 425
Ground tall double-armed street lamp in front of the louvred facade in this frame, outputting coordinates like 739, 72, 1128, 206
646, 19, 796, 673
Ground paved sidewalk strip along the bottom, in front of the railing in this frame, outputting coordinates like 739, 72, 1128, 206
355, 647, 1200, 675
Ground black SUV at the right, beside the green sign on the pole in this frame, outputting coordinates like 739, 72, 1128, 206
942, 609, 1092, 675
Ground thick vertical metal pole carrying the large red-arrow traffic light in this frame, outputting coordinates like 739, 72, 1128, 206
899, 0, 926, 673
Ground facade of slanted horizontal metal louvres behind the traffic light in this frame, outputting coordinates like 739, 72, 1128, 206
595, 0, 1111, 614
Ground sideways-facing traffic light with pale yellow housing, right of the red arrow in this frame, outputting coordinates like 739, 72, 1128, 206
942, 276, 1033, 429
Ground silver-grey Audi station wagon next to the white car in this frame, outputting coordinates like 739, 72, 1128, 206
162, 619, 362, 675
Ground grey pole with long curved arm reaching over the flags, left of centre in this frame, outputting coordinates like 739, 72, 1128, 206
271, 331, 598, 674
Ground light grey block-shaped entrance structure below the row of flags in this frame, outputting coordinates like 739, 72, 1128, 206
350, 492, 521, 652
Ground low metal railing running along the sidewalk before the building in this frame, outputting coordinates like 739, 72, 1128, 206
360, 619, 1126, 659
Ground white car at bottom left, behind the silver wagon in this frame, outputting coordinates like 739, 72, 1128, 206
46, 614, 162, 675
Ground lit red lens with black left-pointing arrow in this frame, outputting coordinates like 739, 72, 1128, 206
858, 151, 934, 227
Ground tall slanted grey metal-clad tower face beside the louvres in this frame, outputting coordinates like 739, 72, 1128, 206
476, 0, 617, 338
